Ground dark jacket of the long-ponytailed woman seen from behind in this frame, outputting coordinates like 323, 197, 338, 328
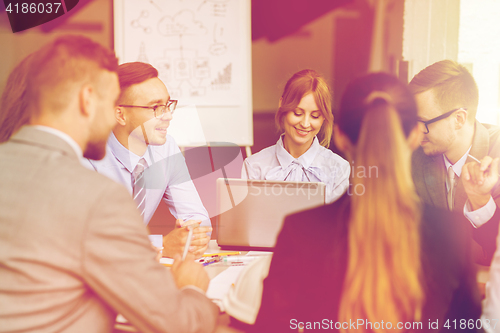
250, 195, 481, 332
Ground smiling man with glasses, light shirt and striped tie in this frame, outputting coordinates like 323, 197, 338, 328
88, 62, 212, 257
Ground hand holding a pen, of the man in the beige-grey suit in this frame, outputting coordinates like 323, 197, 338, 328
171, 254, 210, 292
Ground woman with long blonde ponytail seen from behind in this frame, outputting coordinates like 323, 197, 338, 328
252, 73, 481, 332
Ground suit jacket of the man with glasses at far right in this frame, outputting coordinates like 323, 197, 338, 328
412, 121, 500, 264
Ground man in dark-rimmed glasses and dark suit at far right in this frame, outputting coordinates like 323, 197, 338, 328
410, 60, 500, 263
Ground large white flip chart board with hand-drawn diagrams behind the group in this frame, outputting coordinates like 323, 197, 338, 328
113, 0, 253, 146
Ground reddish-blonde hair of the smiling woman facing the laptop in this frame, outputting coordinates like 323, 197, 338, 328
275, 69, 333, 148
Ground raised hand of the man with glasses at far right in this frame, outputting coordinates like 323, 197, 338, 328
460, 156, 499, 210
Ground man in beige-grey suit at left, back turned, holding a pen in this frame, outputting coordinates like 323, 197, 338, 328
0, 36, 218, 332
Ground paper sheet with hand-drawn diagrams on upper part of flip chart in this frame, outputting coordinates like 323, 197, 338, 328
117, 0, 244, 106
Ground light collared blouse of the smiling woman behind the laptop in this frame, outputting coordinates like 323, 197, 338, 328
241, 137, 350, 203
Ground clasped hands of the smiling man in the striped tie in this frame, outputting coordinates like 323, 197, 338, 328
163, 220, 212, 259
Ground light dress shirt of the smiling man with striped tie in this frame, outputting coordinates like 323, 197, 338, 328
83, 133, 211, 226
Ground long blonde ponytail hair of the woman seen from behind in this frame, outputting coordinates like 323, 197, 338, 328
338, 73, 424, 332
